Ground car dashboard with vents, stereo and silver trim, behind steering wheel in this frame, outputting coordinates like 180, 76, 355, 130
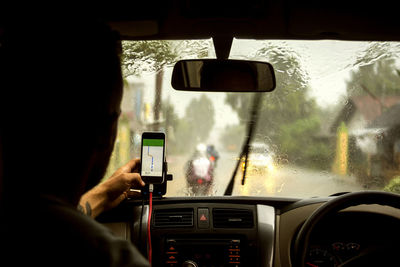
98, 197, 400, 266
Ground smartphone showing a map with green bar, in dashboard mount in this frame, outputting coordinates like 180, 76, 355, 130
140, 132, 165, 184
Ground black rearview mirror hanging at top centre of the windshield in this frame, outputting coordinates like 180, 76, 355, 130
171, 59, 276, 92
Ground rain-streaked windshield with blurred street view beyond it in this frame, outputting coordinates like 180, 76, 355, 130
104, 39, 400, 197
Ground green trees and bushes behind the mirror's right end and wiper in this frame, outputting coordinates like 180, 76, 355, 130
226, 42, 331, 169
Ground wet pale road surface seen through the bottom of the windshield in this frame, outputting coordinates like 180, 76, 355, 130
167, 152, 363, 198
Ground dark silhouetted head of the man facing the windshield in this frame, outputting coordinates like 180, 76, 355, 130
1, 18, 122, 205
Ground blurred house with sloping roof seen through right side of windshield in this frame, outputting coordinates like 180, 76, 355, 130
330, 95, 400, 187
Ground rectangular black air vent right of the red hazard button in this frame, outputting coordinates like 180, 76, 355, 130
213, 209, 254, 228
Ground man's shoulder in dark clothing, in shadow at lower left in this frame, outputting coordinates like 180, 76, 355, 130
2, 199, 149, 266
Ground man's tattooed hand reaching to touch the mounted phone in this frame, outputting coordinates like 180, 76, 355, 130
78, 159, 144, 218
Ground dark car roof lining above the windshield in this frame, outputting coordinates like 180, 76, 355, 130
102, 0, 400, 41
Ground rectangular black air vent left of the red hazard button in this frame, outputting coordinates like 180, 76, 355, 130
153, 209, 193, 228
